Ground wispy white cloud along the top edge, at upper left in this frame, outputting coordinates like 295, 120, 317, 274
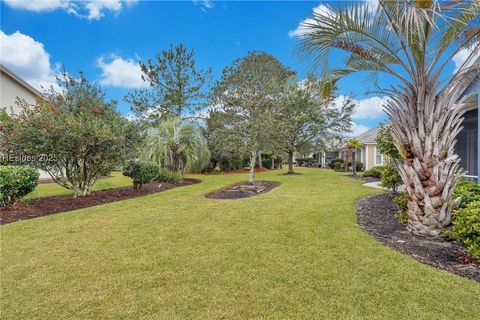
5, 0, 138, 20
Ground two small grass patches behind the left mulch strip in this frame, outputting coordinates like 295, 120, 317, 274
25, 171, 132, 200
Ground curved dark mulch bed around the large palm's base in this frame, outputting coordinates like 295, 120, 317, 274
356, 193, 480, 282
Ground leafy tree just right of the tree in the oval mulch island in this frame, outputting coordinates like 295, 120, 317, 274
275, 77, 354, 174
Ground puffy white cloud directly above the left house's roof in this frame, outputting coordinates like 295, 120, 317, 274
0, 30, 57, 89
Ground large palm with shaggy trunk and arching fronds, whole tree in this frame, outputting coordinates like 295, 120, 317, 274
301, 0, 480, 236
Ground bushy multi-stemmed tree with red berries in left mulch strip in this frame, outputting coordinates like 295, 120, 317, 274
2, 72, 140, 197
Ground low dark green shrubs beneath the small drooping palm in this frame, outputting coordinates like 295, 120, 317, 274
123, 160, 183, 188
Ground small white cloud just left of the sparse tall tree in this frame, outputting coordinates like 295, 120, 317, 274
97, 55, 149, 88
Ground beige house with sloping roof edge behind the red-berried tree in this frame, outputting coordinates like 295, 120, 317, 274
0, 64, 50, 179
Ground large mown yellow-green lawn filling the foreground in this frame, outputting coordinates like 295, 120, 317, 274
1, 169, 480, 319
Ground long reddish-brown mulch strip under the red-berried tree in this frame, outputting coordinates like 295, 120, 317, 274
0, 179, 200, 225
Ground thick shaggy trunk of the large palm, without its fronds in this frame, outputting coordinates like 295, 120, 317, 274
386, 87, 464, 236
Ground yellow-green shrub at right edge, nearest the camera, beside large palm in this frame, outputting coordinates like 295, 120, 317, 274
447, 200, 480, 260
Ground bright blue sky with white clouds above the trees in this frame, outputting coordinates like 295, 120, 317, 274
0, 0, 464, 133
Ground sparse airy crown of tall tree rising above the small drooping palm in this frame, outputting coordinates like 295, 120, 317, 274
125, 44, 211, 122
